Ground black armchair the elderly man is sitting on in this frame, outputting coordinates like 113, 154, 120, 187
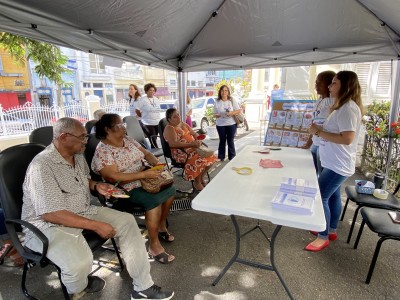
0, 143, 123, 299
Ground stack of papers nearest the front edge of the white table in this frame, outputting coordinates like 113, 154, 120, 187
272, 191, 315, 215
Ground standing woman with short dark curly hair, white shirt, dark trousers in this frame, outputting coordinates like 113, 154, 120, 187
136, 83, 161, 148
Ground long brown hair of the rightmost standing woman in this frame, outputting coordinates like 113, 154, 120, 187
332, 71, 364, 115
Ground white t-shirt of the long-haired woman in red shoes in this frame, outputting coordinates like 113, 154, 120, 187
319, 100, 361, 176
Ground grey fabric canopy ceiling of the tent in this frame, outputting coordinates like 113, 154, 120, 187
0, 0, 400, 71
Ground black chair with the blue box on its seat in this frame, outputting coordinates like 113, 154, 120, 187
340, 181, 400, 243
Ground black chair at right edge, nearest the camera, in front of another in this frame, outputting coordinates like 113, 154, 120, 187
354, 207, 400, 284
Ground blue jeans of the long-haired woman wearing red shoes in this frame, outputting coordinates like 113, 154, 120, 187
318, 168, 347, 240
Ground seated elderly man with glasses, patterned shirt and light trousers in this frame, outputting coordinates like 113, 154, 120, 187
22, 118, 174, 299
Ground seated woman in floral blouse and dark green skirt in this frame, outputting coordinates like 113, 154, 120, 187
92, 114, 175, 263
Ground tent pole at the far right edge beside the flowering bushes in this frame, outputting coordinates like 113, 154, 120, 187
383, 60, 400, 189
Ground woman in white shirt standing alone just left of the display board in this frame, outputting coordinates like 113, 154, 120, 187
214, 85, 241, 161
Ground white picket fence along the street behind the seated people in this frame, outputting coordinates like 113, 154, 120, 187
0, 100, 129, 137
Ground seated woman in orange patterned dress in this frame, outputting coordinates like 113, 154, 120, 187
164, 108, 218, 191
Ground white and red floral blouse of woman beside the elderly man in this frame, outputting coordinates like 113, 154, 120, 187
92, 137, 144, 191
